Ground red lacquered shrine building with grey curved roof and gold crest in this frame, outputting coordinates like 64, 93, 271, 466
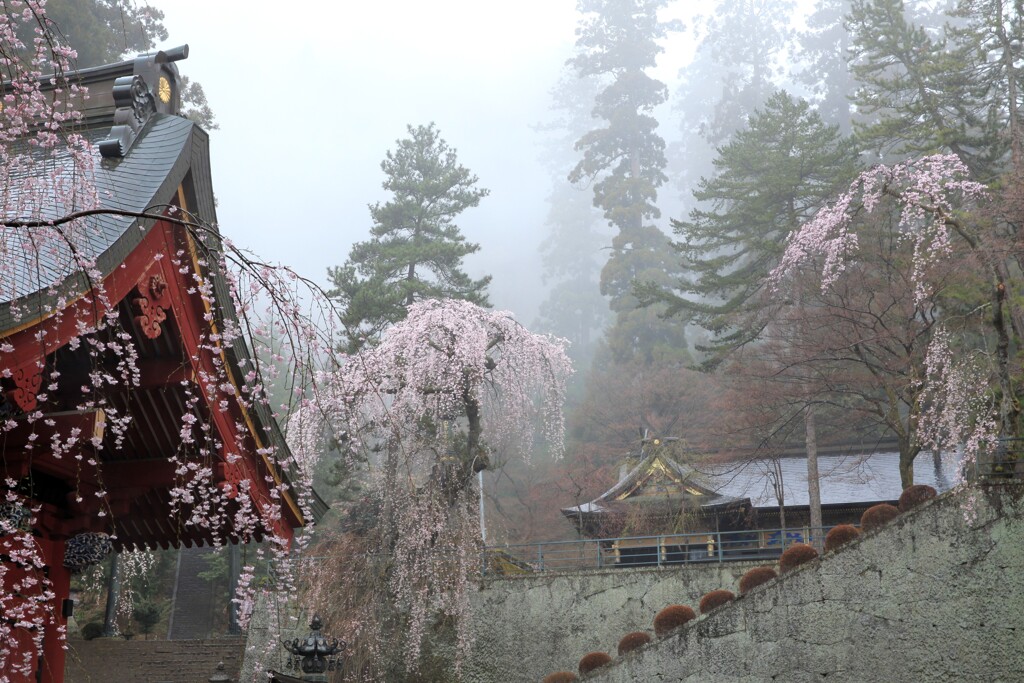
0, 47, 313, 683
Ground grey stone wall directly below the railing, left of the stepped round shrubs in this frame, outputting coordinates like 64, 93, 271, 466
462, 562, 755, 683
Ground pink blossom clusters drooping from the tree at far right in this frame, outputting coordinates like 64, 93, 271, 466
768, 155, 1013, 475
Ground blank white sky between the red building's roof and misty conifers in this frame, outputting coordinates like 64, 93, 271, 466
152, 0, 593, 324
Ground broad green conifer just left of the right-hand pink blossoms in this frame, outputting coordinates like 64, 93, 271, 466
655, 91, 857, 366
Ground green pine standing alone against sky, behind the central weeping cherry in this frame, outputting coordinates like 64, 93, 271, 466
328, 123, 490, 351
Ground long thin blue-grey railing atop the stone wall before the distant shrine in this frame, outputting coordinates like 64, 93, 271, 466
480, 526, 833, 575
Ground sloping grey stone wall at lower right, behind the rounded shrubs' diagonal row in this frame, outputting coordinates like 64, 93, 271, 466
581, 484, 1024, 683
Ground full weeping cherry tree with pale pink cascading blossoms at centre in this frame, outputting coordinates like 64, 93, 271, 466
290, 300, 571, 680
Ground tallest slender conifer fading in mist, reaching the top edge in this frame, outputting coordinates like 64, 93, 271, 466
569, 0, 686, 359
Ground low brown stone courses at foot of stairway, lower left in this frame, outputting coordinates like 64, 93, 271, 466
65, 638, 245, 683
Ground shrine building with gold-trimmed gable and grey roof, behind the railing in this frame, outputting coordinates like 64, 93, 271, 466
561, 438, 952, 566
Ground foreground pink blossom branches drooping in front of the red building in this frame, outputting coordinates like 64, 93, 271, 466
0, 10, 338, 683
